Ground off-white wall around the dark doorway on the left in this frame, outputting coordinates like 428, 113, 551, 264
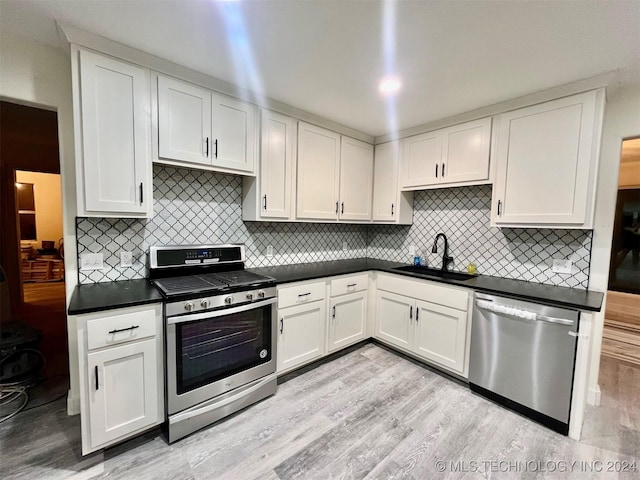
0, 31, 80, 413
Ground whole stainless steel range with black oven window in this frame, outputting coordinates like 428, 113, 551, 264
149, 245, 277, 442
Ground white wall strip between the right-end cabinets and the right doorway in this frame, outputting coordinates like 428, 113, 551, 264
588, 79, 640, 405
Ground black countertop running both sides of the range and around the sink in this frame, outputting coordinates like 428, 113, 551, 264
69, 258, 604, 315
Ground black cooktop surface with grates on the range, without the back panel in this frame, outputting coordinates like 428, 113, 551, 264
153, 270, 275, 297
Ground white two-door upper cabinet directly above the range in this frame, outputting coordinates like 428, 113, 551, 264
158, 75, 256, 175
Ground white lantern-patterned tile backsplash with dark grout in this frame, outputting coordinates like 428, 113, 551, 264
76, 165, 591, 289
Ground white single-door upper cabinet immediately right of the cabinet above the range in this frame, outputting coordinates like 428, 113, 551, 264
242, 110, 298, 221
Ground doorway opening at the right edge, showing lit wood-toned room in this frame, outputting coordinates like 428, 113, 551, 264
602, 138, 640, 364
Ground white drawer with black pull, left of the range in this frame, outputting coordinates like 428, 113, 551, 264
87, 307, 157, 350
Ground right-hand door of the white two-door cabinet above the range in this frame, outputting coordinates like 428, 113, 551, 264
211, 93, 256, 173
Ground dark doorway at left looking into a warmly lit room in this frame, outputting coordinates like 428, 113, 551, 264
0, 101, 69, 404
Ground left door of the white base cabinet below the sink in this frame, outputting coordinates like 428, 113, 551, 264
375, 290, 415, 350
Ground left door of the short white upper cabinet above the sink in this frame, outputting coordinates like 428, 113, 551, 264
402, 130, 442, 187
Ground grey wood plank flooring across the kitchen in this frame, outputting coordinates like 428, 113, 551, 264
0, 343, 640, 480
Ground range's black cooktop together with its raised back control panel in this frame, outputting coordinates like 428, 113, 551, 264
149, 245, 275, 298
